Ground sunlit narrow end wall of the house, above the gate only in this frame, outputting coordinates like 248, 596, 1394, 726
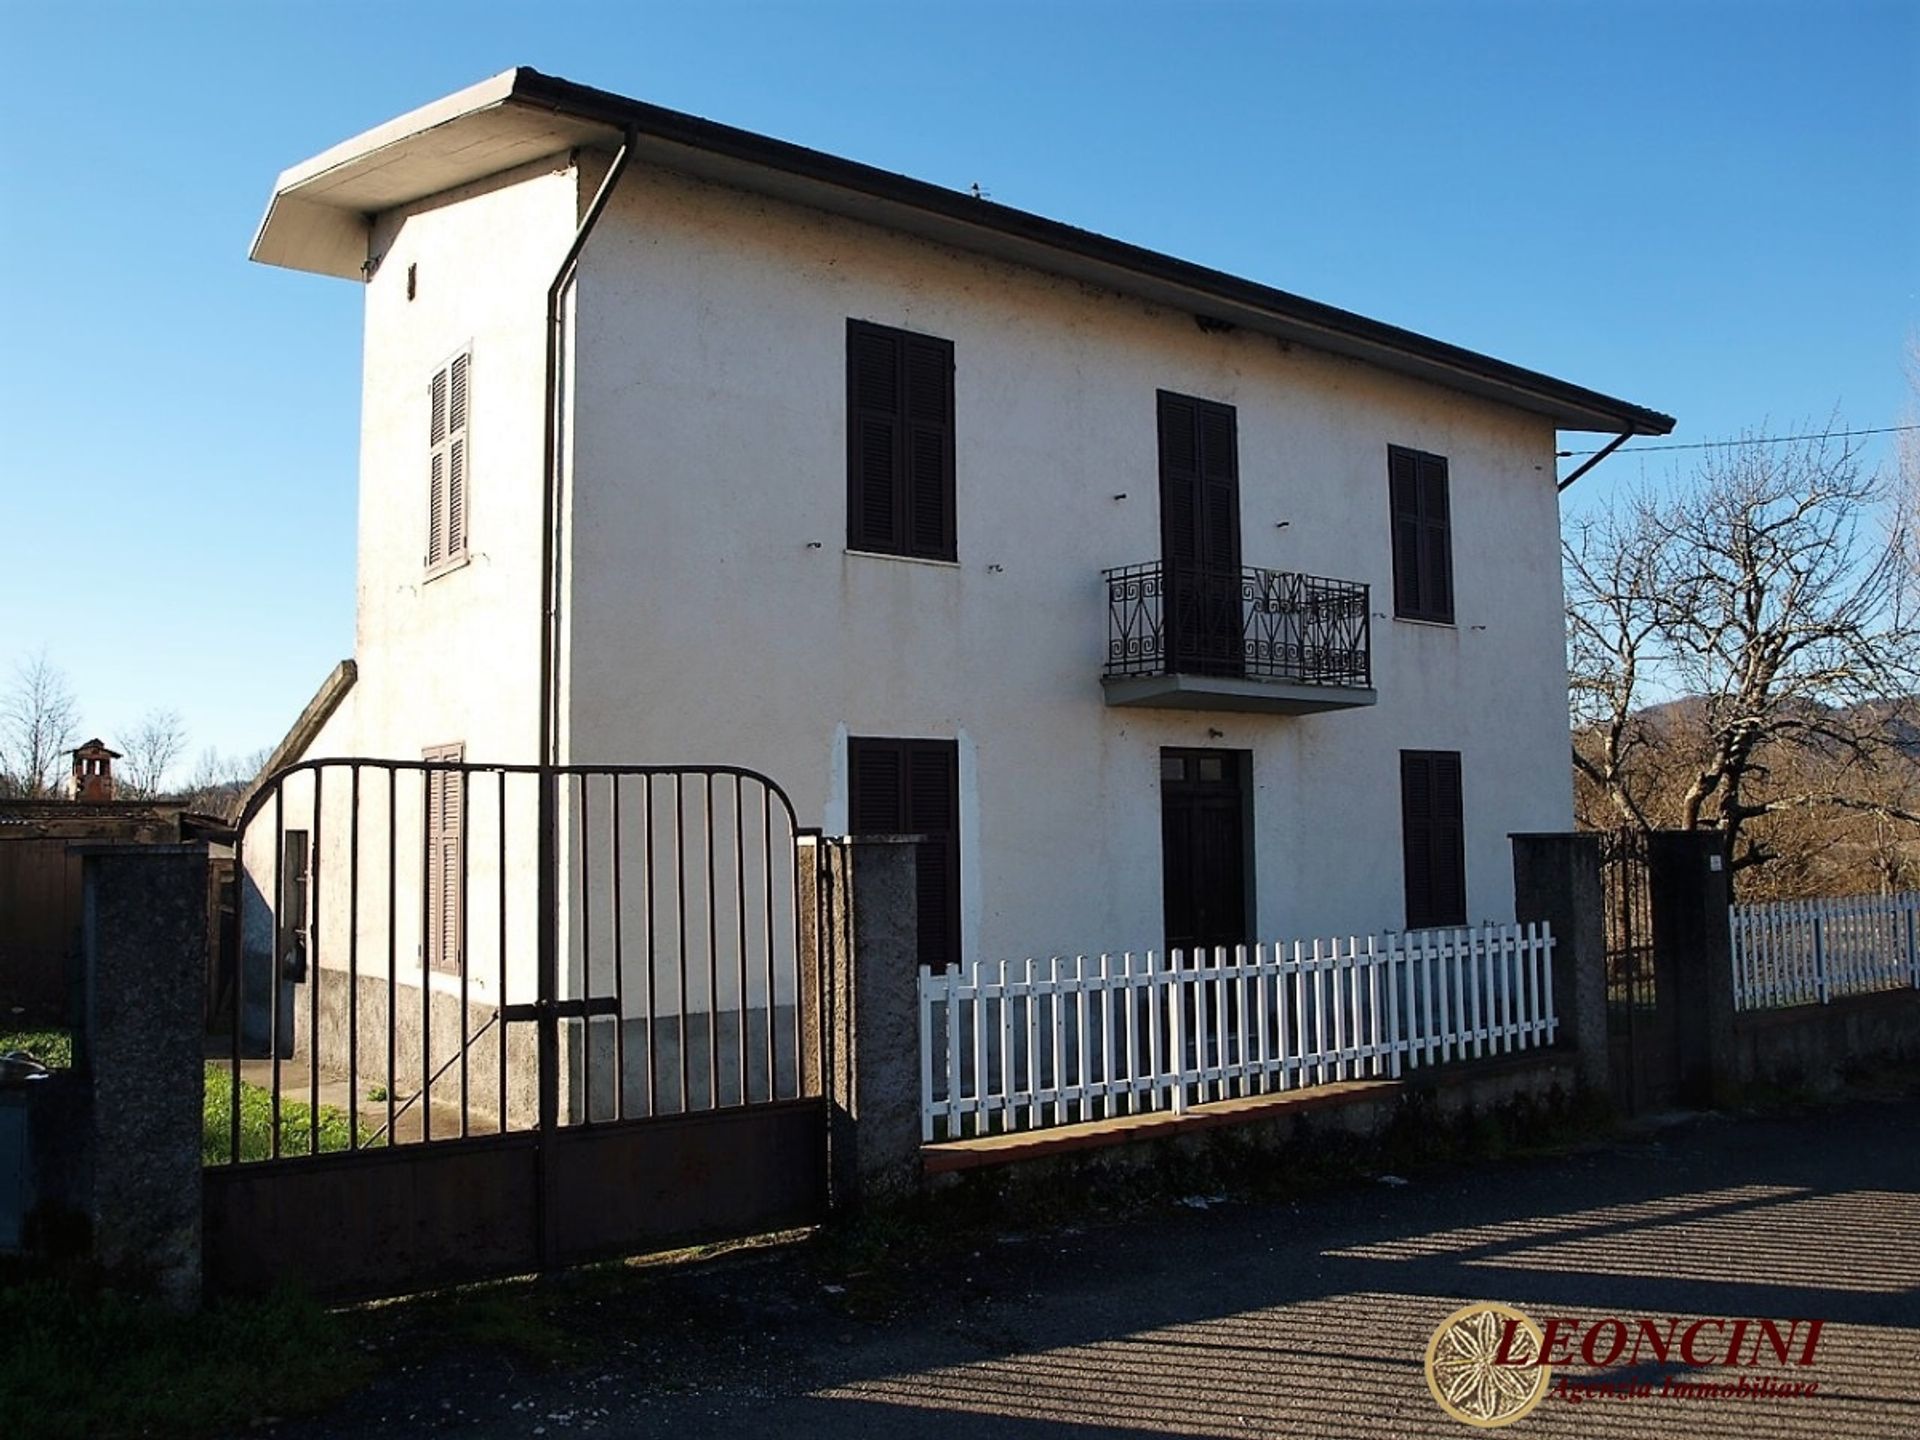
347, 156, 578, 760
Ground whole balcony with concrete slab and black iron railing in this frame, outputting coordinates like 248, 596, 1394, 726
1100, 563, 1377, 714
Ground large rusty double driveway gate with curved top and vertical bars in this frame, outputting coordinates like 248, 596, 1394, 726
204, 758, 828, 1296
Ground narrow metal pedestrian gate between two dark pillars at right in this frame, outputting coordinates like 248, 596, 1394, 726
1599, 829, 1678, 1116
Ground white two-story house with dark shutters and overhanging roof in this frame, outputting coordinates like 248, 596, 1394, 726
252, 69, 1672, 1006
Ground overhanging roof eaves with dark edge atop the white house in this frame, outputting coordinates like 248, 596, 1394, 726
252, 67, 1674, 436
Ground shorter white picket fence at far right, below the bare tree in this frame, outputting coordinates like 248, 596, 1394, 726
1730, 891, 1920, 1010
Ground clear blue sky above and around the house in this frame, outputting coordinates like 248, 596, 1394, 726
0, 0, 1920, 783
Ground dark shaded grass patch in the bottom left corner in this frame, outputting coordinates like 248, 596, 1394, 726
0, 1279, 376, 1440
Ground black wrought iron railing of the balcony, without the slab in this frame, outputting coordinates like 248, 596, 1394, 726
1104, 563, 1373, 689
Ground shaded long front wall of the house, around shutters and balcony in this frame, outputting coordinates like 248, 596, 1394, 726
560, 167, 1572, 958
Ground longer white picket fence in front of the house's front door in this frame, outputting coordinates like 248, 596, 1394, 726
920, 924, 1557, 1140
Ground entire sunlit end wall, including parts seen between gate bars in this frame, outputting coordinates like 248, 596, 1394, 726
266, 156, 578, 1004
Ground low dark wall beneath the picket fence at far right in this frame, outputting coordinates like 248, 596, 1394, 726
1734, 989, 1920, 1091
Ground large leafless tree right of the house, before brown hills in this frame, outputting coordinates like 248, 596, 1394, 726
1567, 422, 1920, 889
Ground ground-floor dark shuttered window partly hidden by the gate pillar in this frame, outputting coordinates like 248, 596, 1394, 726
847, 737, 960, 966
